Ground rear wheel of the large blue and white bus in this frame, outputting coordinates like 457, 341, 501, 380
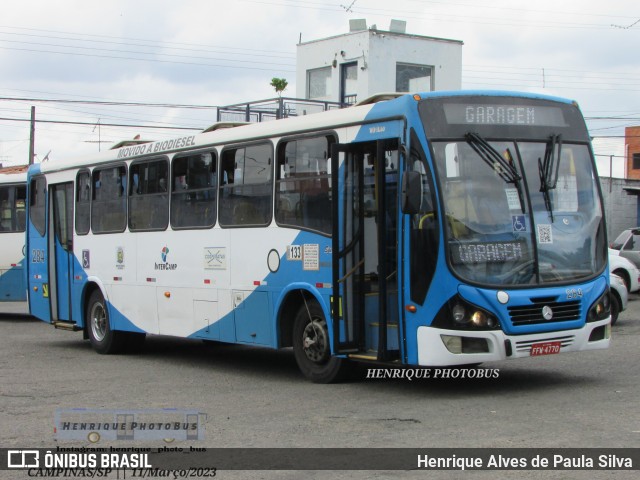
85, 290, 127, 355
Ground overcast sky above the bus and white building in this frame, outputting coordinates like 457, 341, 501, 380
0, 0, 640, 176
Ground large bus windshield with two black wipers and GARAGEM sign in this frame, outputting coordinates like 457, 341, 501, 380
432, 134, 606, 286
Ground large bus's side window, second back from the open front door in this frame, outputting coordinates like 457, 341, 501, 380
218, 143, 273, 227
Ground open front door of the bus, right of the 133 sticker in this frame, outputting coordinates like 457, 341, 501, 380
331, 139, 402, 361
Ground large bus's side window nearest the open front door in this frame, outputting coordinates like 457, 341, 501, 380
275, 136, 335, 234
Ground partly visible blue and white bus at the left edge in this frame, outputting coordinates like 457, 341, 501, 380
0, 166, 27, 304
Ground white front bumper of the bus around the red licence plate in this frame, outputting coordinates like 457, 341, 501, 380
417, 318, 611, 367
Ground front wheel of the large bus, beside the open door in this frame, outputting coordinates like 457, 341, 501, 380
293, 301, 349, 383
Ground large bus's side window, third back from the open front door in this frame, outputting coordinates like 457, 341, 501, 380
171, 151, 217, 228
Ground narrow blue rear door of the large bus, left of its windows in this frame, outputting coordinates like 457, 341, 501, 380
47, 182, 74, 323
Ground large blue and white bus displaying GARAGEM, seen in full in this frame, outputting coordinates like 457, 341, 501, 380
28, 92, 610, 382
